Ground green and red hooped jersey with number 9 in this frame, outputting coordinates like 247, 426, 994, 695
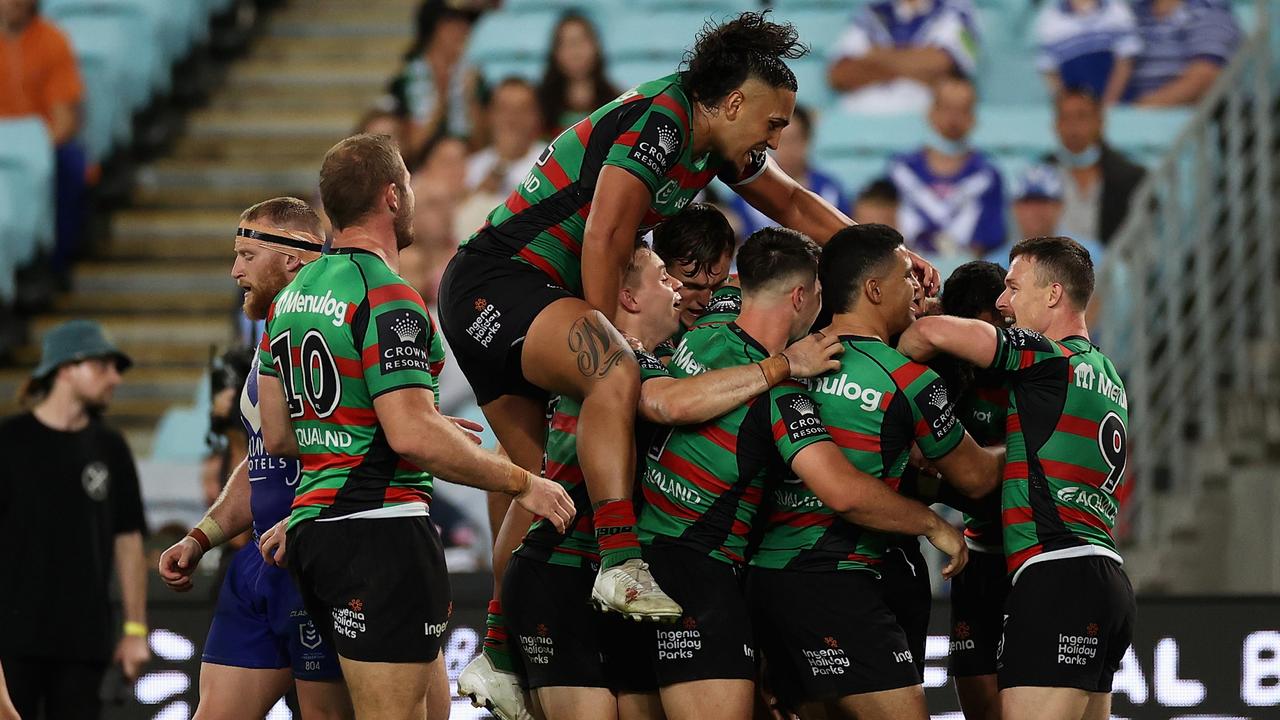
992, 328, 1129, 582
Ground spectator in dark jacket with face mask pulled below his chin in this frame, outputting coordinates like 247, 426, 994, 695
1046, 90, 1146, 243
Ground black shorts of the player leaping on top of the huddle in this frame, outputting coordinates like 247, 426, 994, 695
438, 247, 573, 406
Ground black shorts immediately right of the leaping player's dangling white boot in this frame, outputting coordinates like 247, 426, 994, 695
644, 539, 755, 687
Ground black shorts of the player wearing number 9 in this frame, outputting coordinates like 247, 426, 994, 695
996, 556, 1135, 693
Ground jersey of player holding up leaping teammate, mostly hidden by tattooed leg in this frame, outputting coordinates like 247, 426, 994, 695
516, 351, 671, 568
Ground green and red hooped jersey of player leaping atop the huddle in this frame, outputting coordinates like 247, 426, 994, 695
467, 73, 768, 296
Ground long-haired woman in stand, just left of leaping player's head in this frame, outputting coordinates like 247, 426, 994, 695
538, 12, 620, 137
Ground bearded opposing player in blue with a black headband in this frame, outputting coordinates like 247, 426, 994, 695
160, 197, 355, 720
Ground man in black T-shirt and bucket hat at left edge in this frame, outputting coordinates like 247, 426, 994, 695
0, 320, 150, 719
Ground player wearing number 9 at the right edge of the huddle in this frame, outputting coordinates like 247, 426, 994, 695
899, 237, 1135, 720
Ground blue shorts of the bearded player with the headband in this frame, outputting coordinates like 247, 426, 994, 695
202, 542, 342, 680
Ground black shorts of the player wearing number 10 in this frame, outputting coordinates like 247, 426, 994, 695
287, 518, 453, 662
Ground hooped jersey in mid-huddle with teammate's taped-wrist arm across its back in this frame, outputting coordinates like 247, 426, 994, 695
636, 323, 831, 564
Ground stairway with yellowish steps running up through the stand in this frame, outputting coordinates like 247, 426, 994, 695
0, 0, 419, 448
